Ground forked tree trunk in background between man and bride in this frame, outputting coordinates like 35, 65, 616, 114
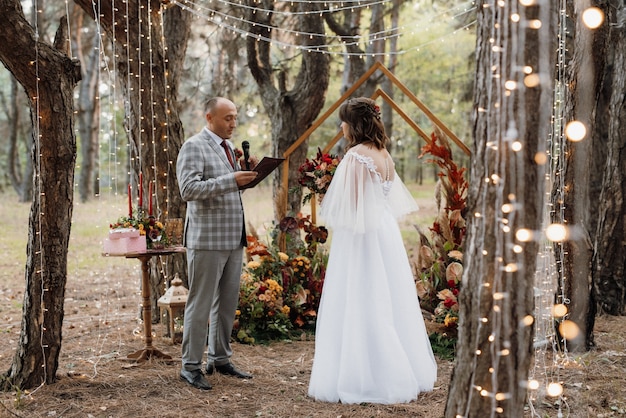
246, 0, 330, 219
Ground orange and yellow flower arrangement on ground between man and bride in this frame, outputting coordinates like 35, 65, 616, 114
233, 216, 328, 343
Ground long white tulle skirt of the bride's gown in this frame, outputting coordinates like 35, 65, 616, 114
309, 212, 437, 404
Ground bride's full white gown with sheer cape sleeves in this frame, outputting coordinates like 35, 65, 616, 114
309, 149, 437, 404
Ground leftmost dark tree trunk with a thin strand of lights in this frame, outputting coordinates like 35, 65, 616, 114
0, 0, 80, 389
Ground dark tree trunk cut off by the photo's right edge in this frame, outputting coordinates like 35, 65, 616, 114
591, 1, 626, 315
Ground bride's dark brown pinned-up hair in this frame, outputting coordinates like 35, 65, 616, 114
339, 97, 389, 149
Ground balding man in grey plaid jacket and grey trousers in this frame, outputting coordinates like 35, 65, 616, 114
176, 97, 257, 390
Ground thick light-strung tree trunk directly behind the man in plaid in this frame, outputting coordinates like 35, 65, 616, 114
75, 0, 191, 322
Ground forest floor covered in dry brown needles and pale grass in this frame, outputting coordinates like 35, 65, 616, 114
0, 189, 626, 418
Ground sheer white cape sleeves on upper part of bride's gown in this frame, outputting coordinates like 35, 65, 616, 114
319, 151, 417, 233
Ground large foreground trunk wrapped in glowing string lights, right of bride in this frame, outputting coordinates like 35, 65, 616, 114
445, 2, 556, 418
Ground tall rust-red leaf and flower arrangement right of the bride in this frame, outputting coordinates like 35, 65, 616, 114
415, 131, 469, 329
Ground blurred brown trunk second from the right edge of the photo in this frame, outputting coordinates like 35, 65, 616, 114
552, 2, 612, 352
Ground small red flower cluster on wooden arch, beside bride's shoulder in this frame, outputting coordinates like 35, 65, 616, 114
298, 148, 340, 203
